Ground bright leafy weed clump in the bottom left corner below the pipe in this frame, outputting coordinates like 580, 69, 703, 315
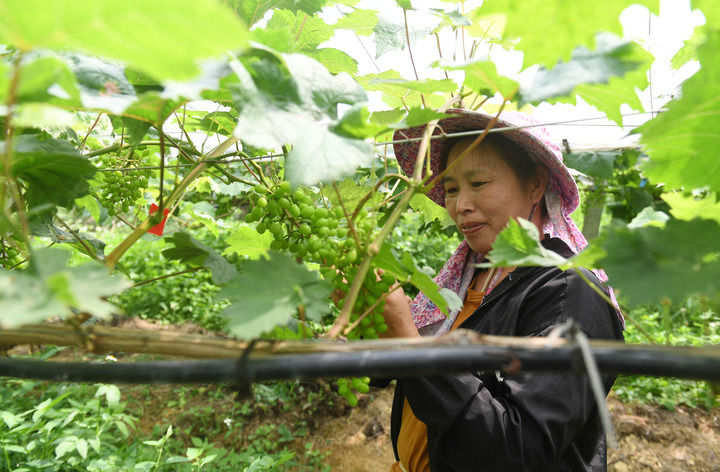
0, 380, 140, 471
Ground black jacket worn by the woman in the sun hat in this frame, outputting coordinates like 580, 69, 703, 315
391, 239, 622, 472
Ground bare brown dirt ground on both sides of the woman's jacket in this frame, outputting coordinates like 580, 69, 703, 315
312, 388, 720, 472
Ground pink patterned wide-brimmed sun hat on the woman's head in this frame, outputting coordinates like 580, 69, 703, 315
393, 108, 580, 217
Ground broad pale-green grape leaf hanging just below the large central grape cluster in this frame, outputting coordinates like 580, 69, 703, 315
217, 251, 332, 339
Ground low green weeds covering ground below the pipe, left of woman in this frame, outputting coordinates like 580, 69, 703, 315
0, 376, 328, 472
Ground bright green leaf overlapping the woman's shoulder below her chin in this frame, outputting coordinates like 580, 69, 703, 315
484, 218, 567, 267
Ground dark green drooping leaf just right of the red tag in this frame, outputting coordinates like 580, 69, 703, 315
162, 232, 237, 285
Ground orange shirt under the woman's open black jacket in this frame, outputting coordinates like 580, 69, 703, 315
390, 280, 484, 472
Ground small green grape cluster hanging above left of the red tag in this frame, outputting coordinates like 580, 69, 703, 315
98, 154, 151, 216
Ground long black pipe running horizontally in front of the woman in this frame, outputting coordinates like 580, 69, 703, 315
0, 342, 720, 384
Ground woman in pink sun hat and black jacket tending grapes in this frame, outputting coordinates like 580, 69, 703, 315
385, 110, 623, 472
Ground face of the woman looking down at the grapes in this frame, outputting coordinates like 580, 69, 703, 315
443, 140, 546, 254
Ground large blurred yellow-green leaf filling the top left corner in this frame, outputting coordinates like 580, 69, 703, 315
0, 0, 247, 80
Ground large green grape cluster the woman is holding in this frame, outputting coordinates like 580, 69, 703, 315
245, 182, 395, 339
